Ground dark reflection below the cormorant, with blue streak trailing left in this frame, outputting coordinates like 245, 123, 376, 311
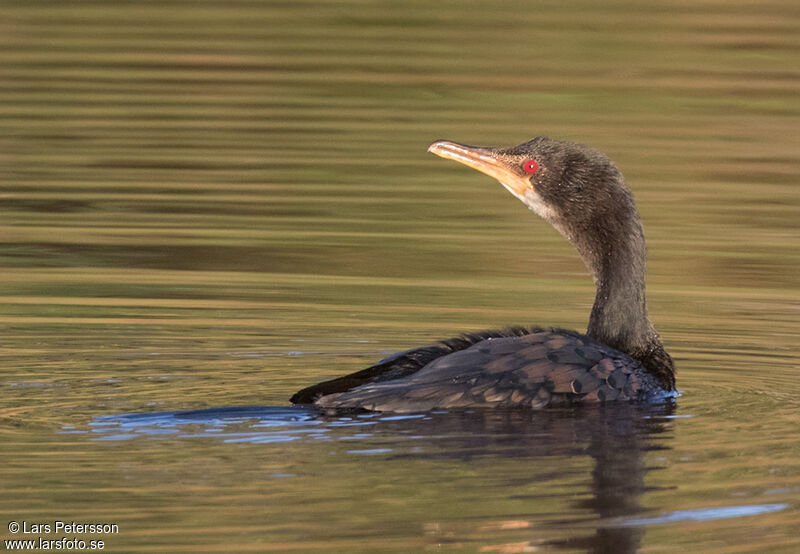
92, 403, 676, 553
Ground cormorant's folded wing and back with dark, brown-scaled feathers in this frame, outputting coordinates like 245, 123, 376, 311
304, 328, 664, 412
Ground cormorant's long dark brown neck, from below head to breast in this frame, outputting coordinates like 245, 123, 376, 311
575, 205, 675, 390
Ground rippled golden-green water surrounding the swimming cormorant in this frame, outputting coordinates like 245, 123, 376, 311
0, 1, 800, 552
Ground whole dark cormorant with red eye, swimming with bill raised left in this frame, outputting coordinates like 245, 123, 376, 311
291, 137, 675, 412
